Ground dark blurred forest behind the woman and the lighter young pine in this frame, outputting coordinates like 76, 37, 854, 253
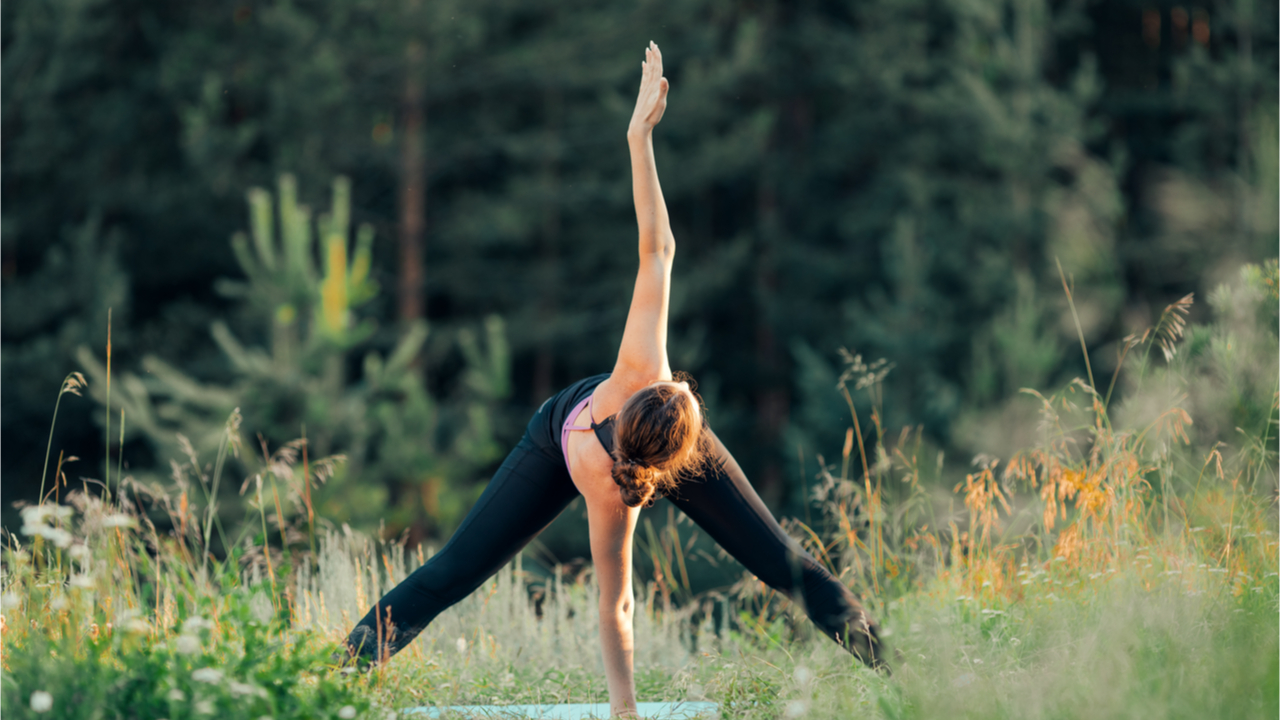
0, 0, 1277, 532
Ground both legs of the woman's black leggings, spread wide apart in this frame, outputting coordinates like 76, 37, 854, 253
347, 422, 881, 665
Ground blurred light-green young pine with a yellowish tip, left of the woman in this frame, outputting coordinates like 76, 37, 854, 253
79, 176, 509, 532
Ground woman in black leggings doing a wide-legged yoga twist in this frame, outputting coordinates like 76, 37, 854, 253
346, 44, 882, 716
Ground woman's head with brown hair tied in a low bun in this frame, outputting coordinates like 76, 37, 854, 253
613, 382, 705, 507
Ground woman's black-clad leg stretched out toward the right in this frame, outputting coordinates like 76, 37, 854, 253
669, 425, 883, 667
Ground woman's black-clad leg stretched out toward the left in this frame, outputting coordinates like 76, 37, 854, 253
347, 434, 579, 662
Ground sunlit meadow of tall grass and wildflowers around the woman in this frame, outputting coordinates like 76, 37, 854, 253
0, 268, 1280, 720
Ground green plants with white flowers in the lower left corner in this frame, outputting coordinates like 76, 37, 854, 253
0, 512, 371, 719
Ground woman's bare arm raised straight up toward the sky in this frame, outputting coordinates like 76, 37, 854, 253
613, 42, 676, 383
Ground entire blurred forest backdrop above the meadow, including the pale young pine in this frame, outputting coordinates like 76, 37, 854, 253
0, 0, 1280, 571
